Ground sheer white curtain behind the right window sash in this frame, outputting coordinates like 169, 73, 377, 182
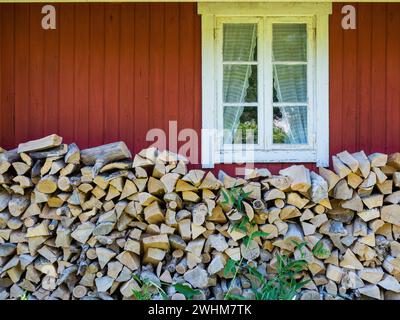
273, 24, 307, 144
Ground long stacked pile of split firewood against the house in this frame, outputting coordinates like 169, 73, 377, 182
0, 135, 400, 300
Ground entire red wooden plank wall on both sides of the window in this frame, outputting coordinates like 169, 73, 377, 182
0, 3, 400, 172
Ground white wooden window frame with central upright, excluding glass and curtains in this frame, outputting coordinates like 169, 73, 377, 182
198, 3, 332, 168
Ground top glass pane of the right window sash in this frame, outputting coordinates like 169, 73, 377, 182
272, 23, 307, 61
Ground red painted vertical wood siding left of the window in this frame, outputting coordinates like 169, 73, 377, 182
0, 3, 201, 152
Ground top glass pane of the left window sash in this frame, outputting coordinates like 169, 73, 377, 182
223, 23, 257, 61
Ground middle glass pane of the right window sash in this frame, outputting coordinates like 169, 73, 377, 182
274, 65, 307, 102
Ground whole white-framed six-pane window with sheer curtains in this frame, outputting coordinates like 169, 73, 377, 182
199, 3, 331, 167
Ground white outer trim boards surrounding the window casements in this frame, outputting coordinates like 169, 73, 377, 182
198, 3, 332, 168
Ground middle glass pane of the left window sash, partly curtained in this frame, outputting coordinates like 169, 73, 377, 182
223, 65, 257, 103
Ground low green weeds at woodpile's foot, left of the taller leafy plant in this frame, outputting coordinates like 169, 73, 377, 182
133, 275, 201, 300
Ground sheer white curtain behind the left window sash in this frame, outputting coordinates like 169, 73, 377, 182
223, 24, 257, 143
